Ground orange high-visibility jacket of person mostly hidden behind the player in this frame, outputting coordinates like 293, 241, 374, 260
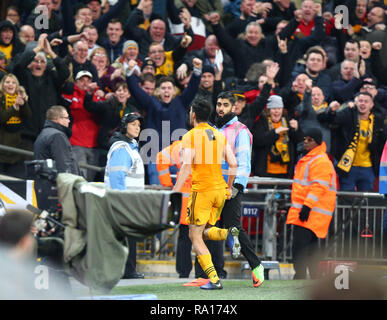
156, 140, 192, 225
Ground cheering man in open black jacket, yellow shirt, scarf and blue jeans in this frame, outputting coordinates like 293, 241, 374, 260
323, 92, 386, 191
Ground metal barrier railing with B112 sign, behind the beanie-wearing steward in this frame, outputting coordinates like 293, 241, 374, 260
241, 177, 387, 262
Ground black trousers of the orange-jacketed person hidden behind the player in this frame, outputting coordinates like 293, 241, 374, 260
176, 224, 227, 279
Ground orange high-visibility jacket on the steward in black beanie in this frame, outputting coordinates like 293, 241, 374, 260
286, 142, 337, 238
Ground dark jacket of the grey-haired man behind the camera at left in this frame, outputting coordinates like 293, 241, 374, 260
34, 120, 79, 175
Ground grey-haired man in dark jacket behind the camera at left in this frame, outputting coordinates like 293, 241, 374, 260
34, 106, 80, 214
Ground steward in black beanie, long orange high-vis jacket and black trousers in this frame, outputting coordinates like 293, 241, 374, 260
286, 128, 337, 279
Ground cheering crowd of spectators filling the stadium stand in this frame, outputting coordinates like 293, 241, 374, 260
0, 0, 387, 191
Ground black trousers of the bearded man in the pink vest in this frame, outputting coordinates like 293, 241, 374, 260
220, 192, 261, 270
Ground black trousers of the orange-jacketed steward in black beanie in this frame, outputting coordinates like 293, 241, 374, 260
293, 225, 318, 279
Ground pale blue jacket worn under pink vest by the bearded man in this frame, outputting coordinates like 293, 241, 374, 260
217, 116, 251, 190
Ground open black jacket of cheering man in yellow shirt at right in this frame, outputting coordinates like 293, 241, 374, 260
318, 107, 387, 176
